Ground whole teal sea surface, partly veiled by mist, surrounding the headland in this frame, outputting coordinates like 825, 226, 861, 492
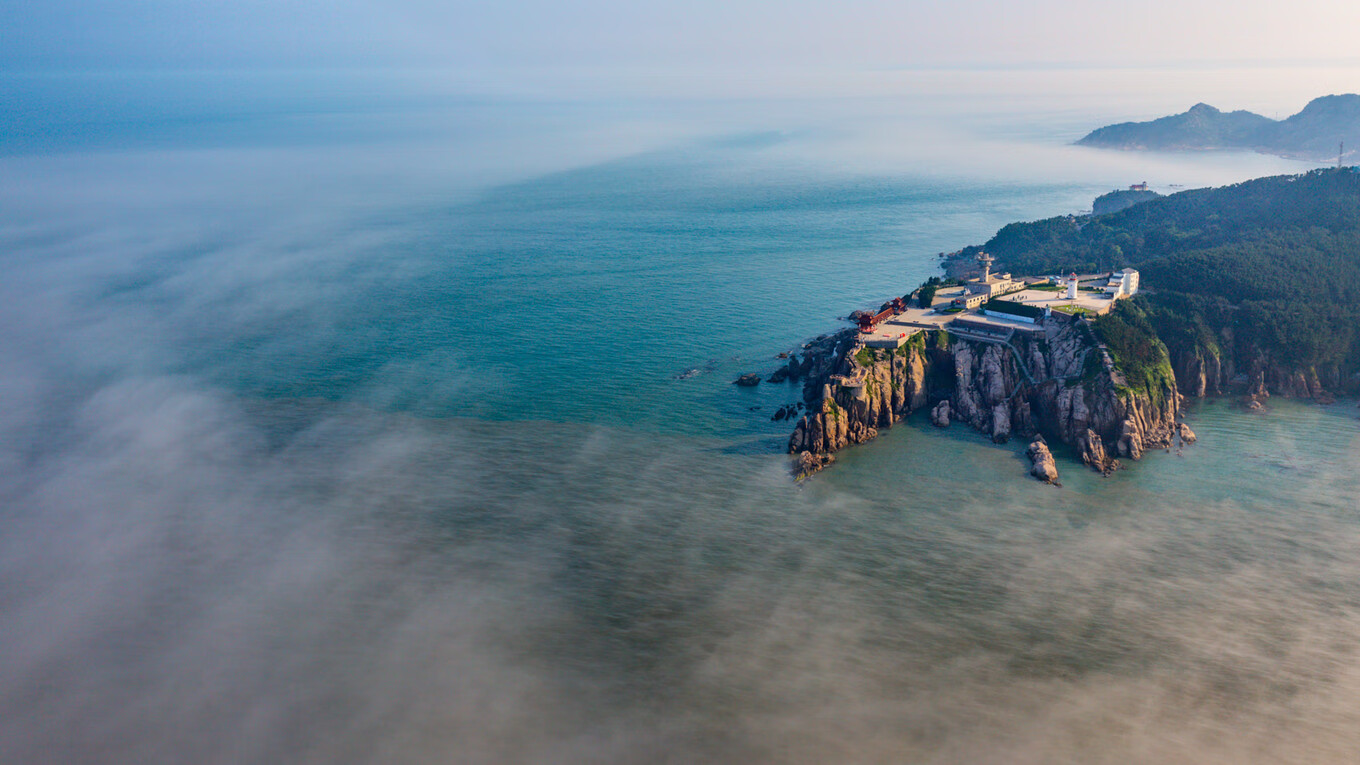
0, 71, 1360, 764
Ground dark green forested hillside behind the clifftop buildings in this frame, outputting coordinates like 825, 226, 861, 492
964, 167, 1360, 388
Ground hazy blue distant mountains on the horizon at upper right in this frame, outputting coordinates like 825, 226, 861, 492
1077, 93, 1360, 159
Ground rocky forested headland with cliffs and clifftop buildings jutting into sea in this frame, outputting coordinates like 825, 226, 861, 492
779, 167, 1360, 482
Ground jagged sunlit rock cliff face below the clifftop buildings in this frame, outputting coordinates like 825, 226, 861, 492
789, 314, 1180, 472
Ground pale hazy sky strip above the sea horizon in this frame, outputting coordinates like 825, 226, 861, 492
0, 0, 1360, 72
